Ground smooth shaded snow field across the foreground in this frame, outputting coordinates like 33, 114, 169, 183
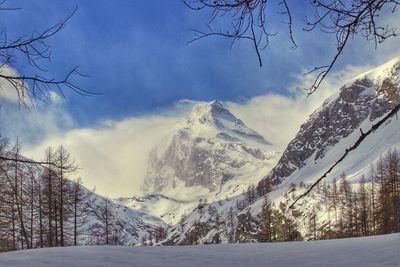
0, 234, 400, 267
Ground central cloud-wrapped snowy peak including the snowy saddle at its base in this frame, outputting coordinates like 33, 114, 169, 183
115, 101, 279, 225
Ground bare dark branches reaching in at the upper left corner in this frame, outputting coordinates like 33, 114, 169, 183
0, 0, 93, 105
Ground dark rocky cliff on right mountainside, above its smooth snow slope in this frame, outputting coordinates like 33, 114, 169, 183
268, 59, 400, 183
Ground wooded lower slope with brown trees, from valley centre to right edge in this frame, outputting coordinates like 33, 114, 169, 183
175, 149, 400, 244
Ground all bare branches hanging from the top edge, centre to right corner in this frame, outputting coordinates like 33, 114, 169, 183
183, 0, 399, 94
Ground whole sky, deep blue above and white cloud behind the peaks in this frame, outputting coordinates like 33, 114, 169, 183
0, 0, 400, 196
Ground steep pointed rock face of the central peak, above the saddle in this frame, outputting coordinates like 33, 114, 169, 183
145, 101, 276, 195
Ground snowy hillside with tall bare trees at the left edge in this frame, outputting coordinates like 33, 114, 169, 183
0, 156, 167, 250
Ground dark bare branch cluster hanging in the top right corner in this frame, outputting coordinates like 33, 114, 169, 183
304, 0, 399, 95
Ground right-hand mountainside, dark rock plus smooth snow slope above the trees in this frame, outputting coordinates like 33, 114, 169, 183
267, 58, 400, 188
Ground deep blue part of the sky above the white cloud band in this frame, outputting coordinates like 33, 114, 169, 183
1, 0, 350, 125
